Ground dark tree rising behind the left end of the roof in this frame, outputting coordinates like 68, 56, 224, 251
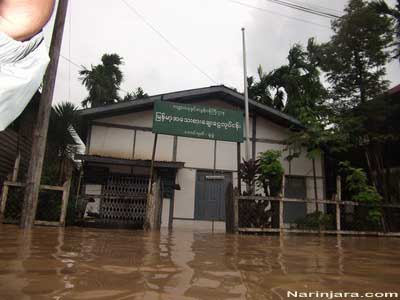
79, 54, 123, 108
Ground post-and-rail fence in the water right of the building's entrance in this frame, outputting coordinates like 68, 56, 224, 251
232, 176, 400, 237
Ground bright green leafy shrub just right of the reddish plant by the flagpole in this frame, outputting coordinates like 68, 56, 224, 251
257, 150, 285, 197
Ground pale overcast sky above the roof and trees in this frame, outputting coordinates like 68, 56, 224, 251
44, 0, 400, 105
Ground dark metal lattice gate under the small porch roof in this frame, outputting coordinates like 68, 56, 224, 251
100, 174, 149, 228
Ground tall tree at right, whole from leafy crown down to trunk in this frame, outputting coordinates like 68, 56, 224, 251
319, 0, 393, 202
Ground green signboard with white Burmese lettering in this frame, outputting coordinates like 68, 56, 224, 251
153, 100, 243, 142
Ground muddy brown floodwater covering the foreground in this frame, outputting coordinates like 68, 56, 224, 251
0, 225, 400, 300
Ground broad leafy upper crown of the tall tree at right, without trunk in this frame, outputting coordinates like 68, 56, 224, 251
320, 0, 393, 108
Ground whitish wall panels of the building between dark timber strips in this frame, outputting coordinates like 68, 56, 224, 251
88, 99, 324, 219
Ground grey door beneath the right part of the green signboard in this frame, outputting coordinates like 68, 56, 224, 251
194, 171, 232, 221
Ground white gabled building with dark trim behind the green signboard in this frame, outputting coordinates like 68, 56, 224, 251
78, 86, 325, 231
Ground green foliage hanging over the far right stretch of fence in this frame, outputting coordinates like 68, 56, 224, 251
339, 162, 382, 226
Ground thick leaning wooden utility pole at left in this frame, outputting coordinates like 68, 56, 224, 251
20, 0, 68, 229
